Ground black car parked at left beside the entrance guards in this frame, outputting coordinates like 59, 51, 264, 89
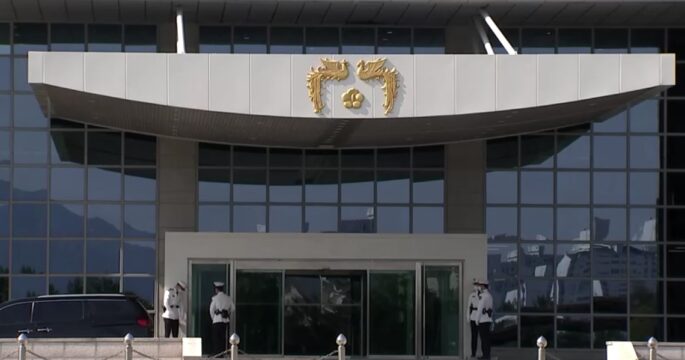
0, 294, 153, 338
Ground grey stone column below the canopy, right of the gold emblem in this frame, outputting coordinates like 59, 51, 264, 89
445, 140, 486, 234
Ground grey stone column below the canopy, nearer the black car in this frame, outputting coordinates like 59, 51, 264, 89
157, 137, 198, 336
